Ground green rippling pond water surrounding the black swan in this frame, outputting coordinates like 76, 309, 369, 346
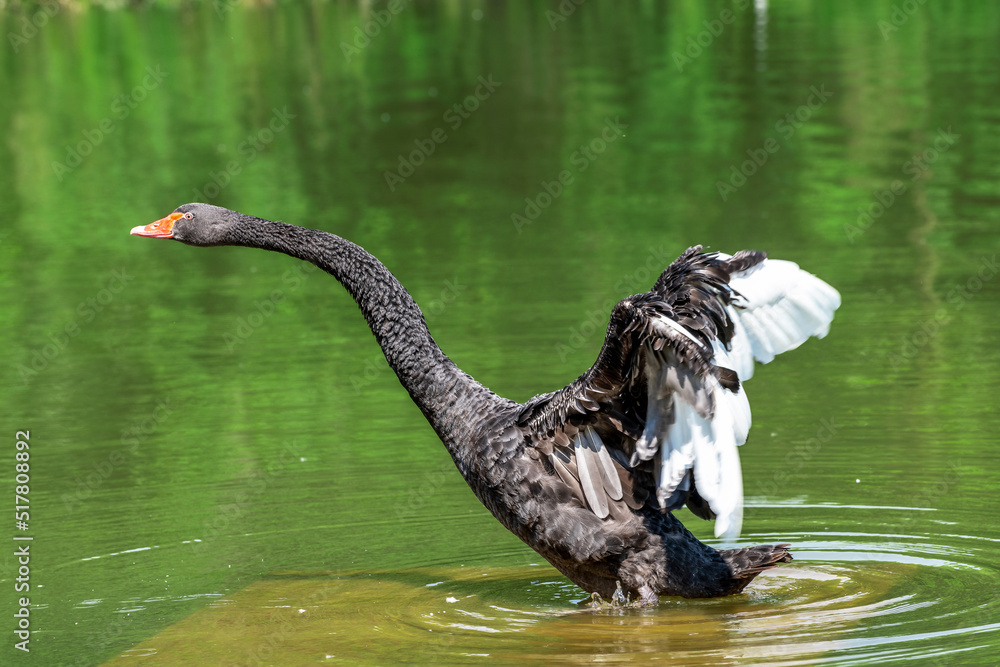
0, 0, 1000, 665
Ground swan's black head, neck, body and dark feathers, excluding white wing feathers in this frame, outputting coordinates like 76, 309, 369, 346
133, 204, 844, 603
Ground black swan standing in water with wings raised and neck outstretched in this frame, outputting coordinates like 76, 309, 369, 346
131, 204, 840, 605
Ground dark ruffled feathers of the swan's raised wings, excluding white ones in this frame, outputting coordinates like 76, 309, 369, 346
517, 246, 766, 518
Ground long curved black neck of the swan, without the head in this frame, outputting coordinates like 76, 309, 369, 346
228, 216, 510, 460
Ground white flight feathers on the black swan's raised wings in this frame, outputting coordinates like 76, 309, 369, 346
633, 253, 840, 538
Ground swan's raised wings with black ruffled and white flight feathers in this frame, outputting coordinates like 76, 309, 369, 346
519, 246, 840, 537
